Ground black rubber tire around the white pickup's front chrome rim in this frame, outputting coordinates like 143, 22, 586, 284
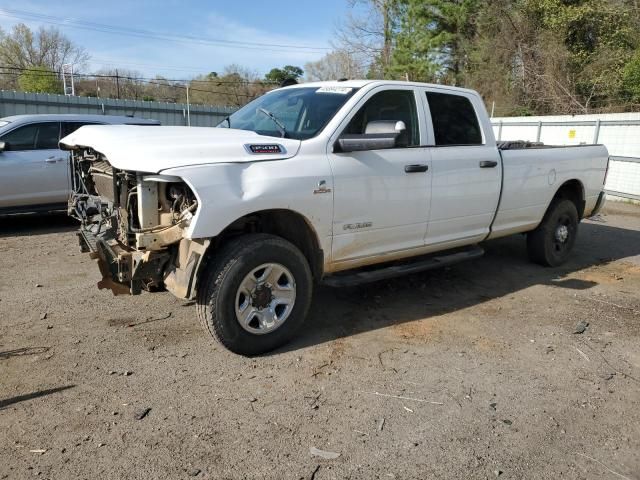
196, 234, 313, 356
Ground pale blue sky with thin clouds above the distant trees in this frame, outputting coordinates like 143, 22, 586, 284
0, 0, 348, 79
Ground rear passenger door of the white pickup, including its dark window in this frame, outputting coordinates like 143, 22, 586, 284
422, 89, 502, 246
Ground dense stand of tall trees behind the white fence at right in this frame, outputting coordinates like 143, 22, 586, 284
332, 0, 640, 114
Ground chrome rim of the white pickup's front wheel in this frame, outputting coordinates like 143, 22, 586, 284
235, 263, 296, 335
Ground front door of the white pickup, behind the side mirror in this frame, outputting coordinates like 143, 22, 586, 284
329, 86, 431, 264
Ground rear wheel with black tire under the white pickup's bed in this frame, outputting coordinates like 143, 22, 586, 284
527, 199, 580, 267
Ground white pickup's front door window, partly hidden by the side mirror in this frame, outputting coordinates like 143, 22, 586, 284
343, 90, 420, 147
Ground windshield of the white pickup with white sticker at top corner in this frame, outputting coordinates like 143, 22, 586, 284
218, 86, 357, 140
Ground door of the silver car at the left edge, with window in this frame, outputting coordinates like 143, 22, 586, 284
0, 122, 64, 208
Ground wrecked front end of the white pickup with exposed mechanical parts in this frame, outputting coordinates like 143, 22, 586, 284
69, 148, 208, 298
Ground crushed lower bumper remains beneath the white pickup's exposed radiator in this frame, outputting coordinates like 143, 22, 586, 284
78, 229, 171, 295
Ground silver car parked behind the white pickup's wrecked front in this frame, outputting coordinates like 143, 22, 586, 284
0, 115, 160, 214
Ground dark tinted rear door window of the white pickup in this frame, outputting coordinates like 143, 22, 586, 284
427, 92, 482, 145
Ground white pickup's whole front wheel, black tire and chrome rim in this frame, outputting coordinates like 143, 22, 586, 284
197, 234, 313, 355
